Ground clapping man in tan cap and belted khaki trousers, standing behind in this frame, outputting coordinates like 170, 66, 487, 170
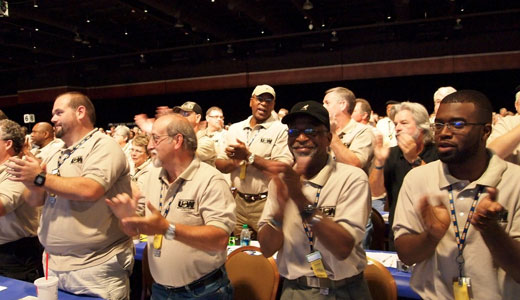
216, 84, 292, 238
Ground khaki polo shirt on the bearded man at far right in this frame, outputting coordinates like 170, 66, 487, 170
393, 155, 520, 300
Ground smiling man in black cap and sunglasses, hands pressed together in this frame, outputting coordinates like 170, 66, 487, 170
258, 101, 370, 299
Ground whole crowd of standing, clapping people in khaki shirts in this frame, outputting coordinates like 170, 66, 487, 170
0, 84, 520, 299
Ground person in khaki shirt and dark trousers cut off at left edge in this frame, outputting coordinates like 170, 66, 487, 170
0, 120, 43, 282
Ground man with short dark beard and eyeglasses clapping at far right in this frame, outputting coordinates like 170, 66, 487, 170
393, 90, 520, 299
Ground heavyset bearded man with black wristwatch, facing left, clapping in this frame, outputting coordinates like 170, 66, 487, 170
8, 92, 133, 299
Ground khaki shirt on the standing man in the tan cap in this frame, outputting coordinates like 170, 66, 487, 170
219, 116, 293, 194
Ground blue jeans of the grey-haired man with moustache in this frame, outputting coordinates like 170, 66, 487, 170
151, 267, 233, 300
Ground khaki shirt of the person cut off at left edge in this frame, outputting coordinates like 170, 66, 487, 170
0, 164, 40, 245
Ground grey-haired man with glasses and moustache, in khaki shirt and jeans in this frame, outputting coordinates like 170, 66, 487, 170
107, 114, 235, 300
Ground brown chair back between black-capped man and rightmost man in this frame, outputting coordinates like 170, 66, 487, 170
364, 258, 397, 300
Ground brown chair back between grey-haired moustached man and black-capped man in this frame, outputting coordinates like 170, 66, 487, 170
226, 246, 280, 300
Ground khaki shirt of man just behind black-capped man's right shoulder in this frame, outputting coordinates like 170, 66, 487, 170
338, 119, 374, 174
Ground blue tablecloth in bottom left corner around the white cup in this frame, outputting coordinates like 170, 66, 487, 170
0, 276, 103, 300
